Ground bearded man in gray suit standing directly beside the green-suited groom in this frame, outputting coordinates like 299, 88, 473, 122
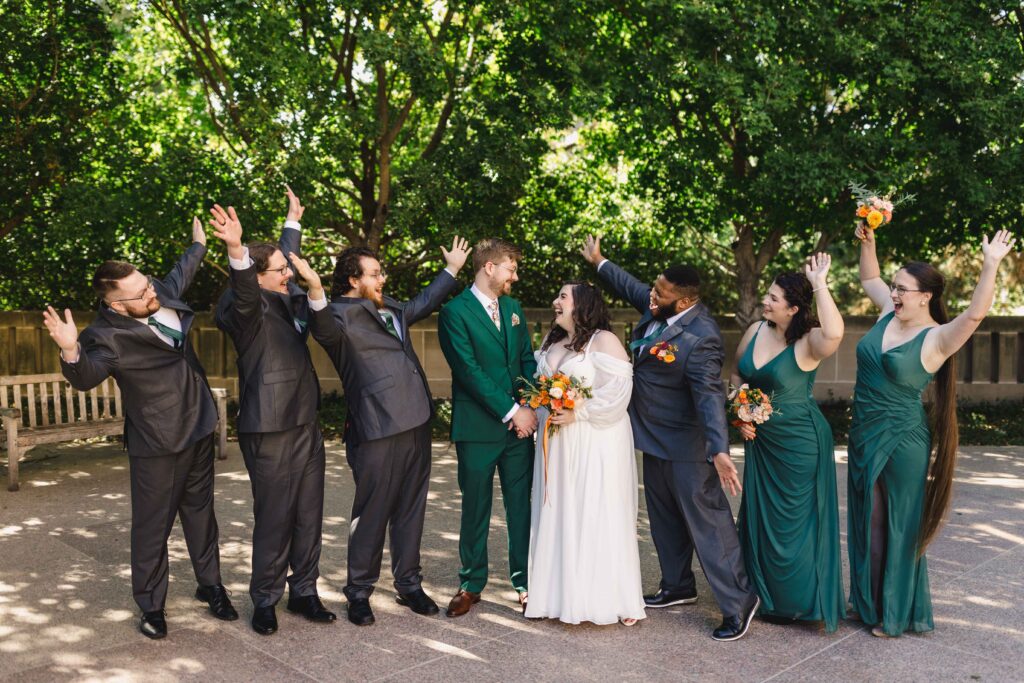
310, 237, 470, 626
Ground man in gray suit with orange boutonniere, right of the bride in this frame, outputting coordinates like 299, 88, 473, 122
583, 238, 761, 641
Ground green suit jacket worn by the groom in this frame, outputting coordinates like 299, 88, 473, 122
437, 288, 537, 441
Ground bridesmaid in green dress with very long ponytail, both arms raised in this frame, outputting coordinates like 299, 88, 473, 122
848, 226, 1014, 638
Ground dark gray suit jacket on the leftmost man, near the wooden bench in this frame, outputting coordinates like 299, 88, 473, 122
60, 242, 217, 458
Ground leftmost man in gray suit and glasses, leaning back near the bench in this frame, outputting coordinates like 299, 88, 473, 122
43, 218, 239, 639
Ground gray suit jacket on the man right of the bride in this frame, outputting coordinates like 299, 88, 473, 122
598, 261, 729, 462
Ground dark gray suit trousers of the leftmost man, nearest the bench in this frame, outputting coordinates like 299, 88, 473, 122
128, 434, 221, 612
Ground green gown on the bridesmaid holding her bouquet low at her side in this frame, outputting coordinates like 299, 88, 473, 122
737, 324, 845, 633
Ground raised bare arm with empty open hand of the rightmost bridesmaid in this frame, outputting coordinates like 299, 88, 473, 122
922, 230, 1016, 372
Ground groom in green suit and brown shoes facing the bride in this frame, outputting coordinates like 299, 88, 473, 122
438, 239, 537, 616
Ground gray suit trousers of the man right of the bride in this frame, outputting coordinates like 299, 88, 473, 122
643, 453, 754, 616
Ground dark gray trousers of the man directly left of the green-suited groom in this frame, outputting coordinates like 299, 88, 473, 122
345, 422, 430, 600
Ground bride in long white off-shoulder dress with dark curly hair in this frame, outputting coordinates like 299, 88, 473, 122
525, 284, 644, 626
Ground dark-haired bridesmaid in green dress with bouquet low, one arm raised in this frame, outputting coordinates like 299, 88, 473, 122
732, 254, 844, 633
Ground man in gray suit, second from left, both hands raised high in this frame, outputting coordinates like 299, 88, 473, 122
211, 191, 336, 635
